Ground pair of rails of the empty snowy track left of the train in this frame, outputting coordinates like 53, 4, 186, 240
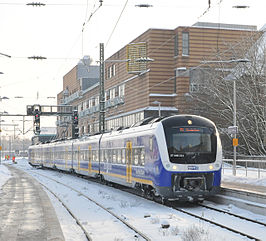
28, 171, 151, 241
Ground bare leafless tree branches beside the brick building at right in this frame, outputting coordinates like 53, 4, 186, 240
189, 32, 266, 155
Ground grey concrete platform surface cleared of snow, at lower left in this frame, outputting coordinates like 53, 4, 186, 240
0, 166, 65, 241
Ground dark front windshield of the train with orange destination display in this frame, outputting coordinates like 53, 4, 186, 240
166, 126, 217, 164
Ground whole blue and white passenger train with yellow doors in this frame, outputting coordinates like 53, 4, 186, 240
29, 115, 222, 201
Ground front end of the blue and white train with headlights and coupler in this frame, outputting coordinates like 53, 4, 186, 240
157, 115, 222, 201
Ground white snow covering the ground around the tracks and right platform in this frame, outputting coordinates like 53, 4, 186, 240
0, 159, 266, 241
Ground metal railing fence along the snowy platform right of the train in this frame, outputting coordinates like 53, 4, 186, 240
223, 159, 266, 178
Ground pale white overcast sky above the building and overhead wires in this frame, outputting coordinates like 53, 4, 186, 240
0, 0, 266, 137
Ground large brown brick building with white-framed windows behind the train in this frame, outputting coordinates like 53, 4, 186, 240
57, 22, 256, 139
